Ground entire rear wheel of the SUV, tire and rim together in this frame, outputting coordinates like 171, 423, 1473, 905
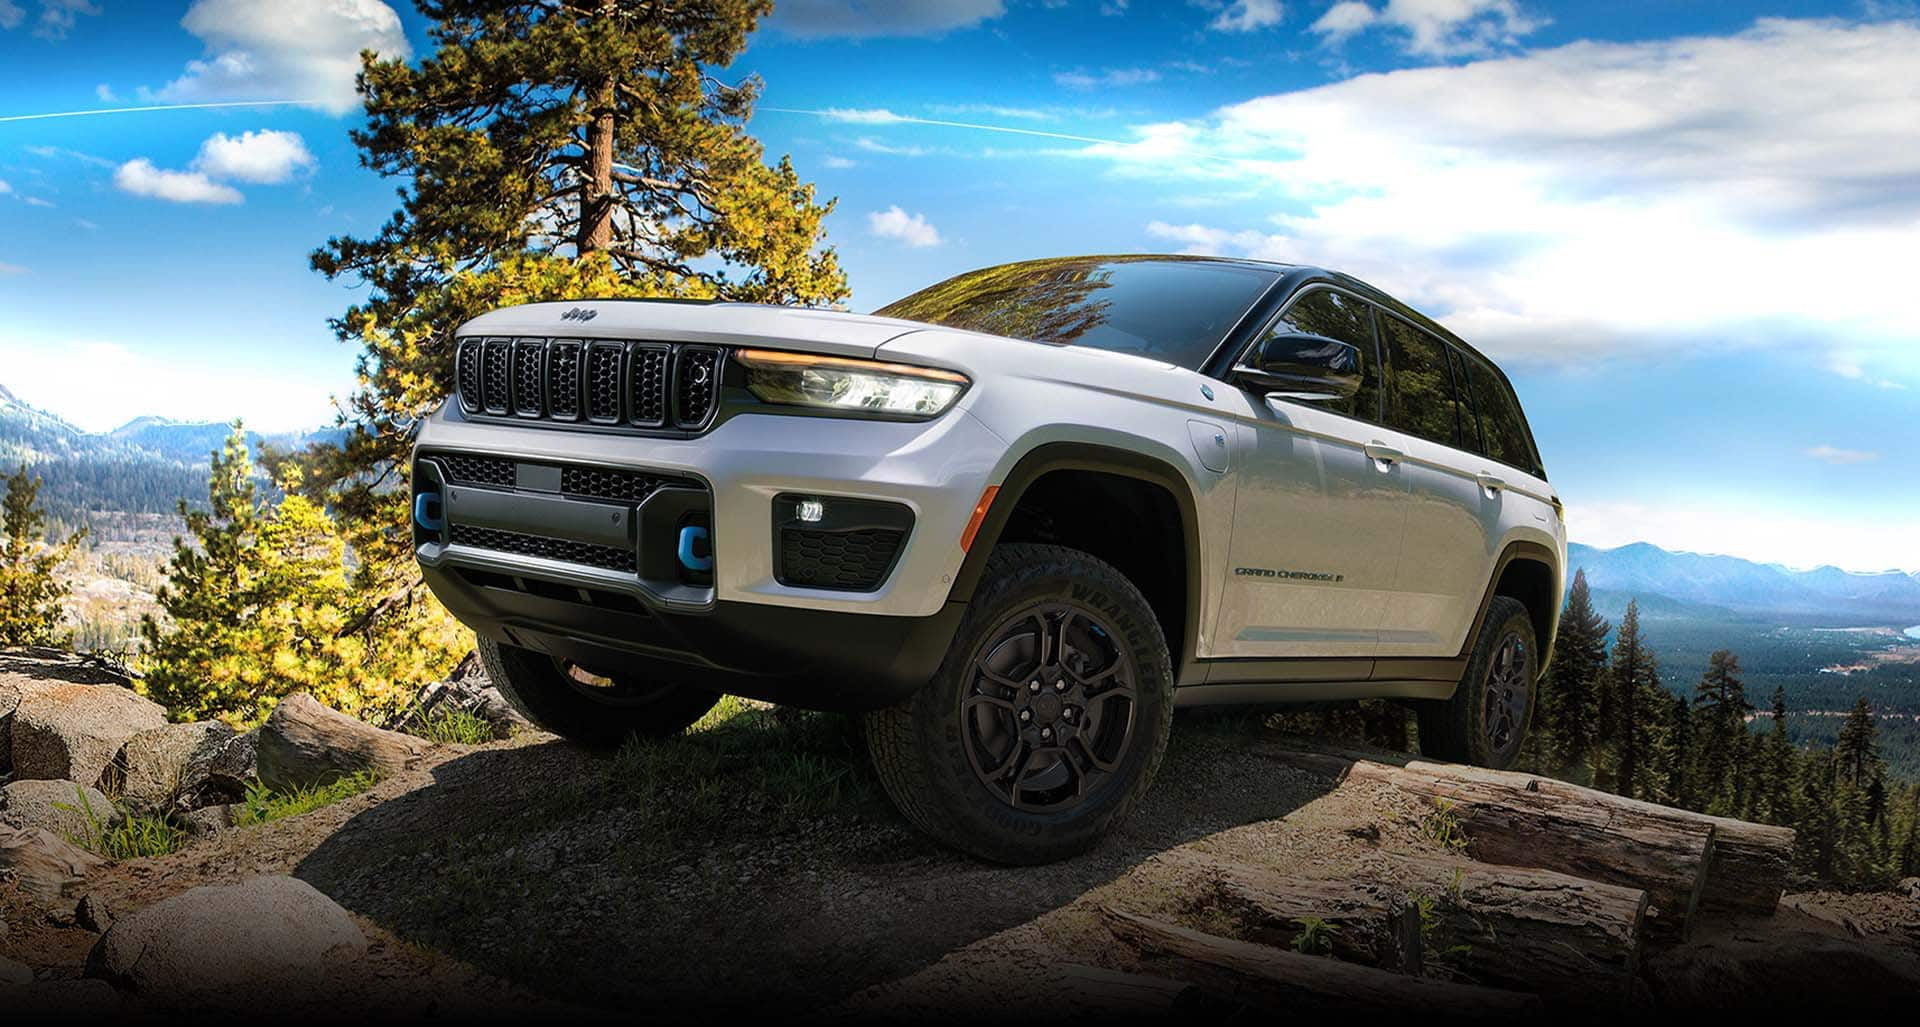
1419, 595, 1540, 770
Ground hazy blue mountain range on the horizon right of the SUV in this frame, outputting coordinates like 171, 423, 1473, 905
1567, 541, 1920, 628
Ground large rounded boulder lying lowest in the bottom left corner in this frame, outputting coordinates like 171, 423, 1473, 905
86, 877, 367, 1010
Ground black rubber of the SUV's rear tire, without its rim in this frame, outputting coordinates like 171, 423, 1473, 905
1417, 595, 1540, 770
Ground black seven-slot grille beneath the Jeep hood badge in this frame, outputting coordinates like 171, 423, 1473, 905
453, 338, 722, 432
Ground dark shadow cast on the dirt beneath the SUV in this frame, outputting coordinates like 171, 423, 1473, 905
296, 722, 1334, 1014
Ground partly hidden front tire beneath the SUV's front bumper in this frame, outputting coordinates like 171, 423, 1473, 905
478, 637, 720, 749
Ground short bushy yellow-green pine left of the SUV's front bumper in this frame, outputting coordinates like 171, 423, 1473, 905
140, 424, 441, 728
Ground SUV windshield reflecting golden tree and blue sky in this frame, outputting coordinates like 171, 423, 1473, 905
874, 257, 1279, 370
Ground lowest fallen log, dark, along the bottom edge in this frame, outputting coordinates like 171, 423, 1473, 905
1104, 908, 1538, 1019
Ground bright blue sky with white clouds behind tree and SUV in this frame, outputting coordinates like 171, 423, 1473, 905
0, 0, 1920, 570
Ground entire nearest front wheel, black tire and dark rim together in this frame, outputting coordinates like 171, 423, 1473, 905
866, 543, 1173, 864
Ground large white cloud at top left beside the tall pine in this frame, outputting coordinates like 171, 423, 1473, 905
154, 0, 413, 115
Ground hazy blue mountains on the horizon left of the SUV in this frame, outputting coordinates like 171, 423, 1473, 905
0, 386, 340, 520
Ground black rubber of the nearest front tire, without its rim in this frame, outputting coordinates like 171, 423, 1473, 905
864, 543, 1173, 864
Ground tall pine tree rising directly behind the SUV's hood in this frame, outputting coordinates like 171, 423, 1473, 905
300, 0, 847, 694
